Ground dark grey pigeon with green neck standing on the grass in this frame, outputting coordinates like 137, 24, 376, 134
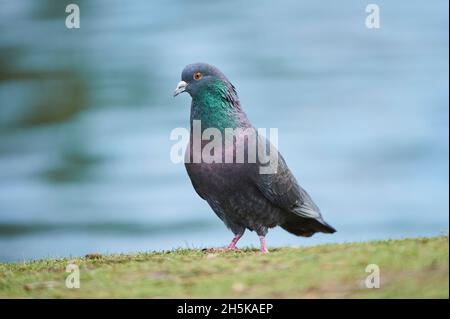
173, 63, 336, 253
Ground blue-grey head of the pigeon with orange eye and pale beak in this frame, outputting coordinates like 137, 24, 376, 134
173, 63, 231, 97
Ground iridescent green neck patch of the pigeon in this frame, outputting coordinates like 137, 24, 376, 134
191, 81, 239, 131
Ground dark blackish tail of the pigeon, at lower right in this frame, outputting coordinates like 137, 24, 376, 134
280, 215, 336, 237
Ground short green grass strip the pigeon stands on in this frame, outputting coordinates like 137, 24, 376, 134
0, 236, 449, 298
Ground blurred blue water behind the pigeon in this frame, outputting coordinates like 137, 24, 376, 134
0, 0, 449, 261
